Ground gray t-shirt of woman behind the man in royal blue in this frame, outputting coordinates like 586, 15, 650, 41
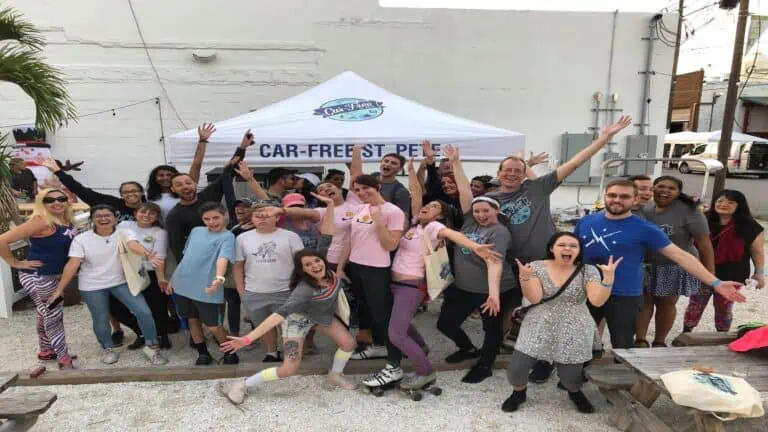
643, 200, 709, 264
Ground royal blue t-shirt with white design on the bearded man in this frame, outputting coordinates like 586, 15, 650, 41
575, 212, 670, 297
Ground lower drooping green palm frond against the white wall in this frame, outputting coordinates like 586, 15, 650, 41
0, 46, 77, 131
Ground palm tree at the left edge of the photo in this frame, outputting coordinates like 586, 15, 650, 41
0, 7, 77, 233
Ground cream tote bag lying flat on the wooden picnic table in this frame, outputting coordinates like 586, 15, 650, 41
661, 369, 765, 421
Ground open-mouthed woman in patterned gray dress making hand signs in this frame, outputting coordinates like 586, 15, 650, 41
501, 232, 622, 413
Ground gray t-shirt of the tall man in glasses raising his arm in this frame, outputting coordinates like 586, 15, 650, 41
488, 171, 560, 262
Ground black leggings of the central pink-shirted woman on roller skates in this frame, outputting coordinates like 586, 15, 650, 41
348, 263, 403, 365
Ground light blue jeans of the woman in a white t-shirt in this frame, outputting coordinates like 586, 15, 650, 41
80, 284, 157, 348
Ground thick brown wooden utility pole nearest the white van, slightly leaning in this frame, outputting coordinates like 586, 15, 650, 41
712, 0, 749, 196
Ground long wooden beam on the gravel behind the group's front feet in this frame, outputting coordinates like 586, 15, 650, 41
16, 355, 511, 386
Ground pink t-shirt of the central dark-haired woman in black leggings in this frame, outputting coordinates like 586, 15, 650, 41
349, 202, 405, 267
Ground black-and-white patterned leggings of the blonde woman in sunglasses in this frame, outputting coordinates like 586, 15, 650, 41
19, 272, 70, 361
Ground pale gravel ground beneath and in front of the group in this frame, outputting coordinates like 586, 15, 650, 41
0, 246, 768, 432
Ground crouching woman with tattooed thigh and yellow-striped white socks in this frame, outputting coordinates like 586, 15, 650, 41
220, 249, 357, 405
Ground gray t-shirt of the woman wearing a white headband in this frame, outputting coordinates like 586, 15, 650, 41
453, 217, 517, 294
